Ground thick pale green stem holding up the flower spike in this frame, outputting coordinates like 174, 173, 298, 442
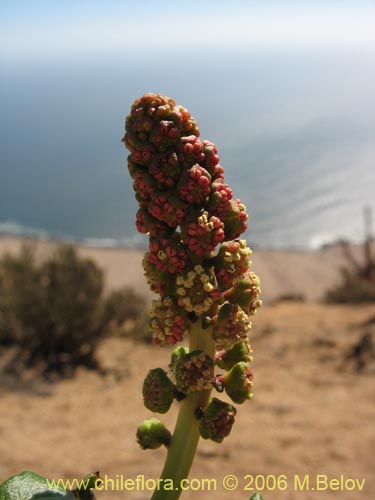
151, 319, 215, 500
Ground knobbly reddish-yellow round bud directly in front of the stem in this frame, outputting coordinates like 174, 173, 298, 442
175, 350, 214, 394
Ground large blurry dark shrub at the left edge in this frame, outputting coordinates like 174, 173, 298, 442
0, 246, 104, 371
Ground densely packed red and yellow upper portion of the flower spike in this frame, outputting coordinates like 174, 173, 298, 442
123, 94, 260, 346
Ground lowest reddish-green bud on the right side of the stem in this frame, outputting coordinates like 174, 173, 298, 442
199, 398, 237, 443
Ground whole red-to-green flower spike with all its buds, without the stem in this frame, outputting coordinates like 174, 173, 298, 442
123, 94, 261, 446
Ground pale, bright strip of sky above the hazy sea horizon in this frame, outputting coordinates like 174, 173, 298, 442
0, 0, 375, 60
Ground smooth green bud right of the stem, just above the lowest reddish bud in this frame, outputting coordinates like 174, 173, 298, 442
217, 361, 253, 404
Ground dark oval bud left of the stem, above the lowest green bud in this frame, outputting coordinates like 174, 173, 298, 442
142, 368, 176, 413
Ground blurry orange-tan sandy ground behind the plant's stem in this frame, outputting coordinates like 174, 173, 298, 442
0, 238, 375, 500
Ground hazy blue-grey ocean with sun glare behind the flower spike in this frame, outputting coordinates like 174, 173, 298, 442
0, 47, 375, 248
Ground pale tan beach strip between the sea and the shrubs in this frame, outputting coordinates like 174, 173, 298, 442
0, 233, 362, 304
